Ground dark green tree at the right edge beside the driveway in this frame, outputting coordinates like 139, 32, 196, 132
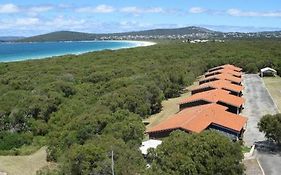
258, 114, 281, 145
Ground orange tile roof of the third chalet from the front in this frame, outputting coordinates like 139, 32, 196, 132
191, 80, 244, 93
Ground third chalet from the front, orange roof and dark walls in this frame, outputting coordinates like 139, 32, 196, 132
191, 80, 244, 97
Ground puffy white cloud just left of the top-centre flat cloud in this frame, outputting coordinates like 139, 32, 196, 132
76, 4, 115, 13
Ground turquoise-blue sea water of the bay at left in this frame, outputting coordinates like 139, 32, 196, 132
0, 41, 136, 62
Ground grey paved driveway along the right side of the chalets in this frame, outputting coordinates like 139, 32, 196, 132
242, 74, 281, 175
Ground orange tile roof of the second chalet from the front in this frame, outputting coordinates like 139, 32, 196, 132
179, 89, 245, 108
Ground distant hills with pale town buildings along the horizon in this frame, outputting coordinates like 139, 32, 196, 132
17, 26, 281, 42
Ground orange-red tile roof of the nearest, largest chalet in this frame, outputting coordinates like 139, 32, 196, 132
146, 104, 247, 133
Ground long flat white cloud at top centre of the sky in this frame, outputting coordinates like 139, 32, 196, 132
120, 6, 165, 14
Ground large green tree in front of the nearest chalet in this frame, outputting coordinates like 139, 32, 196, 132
149, 131, 244, 175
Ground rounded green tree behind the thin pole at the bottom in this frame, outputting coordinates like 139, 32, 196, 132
63, 136, 145, 175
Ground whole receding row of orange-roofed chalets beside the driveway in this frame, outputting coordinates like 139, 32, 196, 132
146, 64, 247, 140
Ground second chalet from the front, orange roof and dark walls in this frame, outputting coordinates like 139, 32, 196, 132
179, 89, 245, 114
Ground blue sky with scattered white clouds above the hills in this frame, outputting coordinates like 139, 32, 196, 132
0, 0, 281, 36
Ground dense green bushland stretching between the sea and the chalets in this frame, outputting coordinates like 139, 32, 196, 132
0, 40, 281, 174
